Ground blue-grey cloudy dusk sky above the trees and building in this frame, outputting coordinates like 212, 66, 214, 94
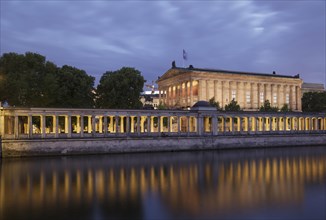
0, 0, 326, 87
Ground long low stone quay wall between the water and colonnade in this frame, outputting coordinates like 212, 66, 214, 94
0, 134, 326, 158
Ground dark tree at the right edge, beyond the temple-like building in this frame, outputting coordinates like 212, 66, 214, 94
302, 92, 326, 112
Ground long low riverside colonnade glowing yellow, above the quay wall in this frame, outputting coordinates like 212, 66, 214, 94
0, 108, 326, 139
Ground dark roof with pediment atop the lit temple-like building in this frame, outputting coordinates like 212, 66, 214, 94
157, 65, 300, 82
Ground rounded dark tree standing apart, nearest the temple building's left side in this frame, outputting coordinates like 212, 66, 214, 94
96, 67, 145, 109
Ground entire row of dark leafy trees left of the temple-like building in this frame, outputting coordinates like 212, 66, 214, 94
0, 52, 145, 108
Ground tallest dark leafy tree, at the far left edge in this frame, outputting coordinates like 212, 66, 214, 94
0, 52, 57, 107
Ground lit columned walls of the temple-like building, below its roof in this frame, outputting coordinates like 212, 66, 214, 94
159, 79, 301, 111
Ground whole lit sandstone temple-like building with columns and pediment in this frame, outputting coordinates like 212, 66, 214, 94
157, 66, 303, 111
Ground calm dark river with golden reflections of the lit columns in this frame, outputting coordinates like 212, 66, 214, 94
0, 146, 326, 220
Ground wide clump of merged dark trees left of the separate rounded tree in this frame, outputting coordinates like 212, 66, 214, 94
0, 52, 94, 107
